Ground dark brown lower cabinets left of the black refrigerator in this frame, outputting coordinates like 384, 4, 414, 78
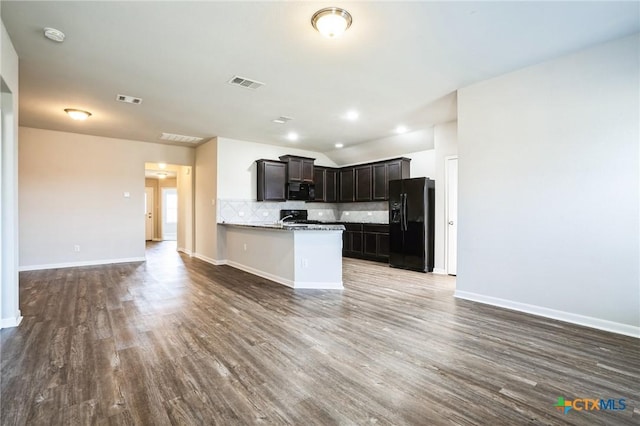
342, 223, 389, 262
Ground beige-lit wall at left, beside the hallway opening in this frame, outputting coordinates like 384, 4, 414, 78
19, 127, 194, 270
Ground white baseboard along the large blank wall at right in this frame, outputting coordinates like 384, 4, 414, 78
454, 290, 640, 338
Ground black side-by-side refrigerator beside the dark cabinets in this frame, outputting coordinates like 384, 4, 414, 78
389, 178, 435, 272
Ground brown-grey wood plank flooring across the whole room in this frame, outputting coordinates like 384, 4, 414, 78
0, 243, 640, 426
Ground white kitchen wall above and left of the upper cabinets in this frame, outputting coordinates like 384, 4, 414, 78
218, 138, 336, 200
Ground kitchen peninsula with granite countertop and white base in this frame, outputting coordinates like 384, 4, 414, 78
220, 222, 345, 290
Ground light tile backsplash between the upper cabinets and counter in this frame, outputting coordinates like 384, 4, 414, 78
217, 198, 389, 223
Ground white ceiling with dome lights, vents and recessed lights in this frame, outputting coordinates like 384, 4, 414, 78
1, 0, 640, 157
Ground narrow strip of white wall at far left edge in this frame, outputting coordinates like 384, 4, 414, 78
0, 18, 22, 328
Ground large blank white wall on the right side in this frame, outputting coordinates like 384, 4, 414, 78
456, 34, 640, 336
